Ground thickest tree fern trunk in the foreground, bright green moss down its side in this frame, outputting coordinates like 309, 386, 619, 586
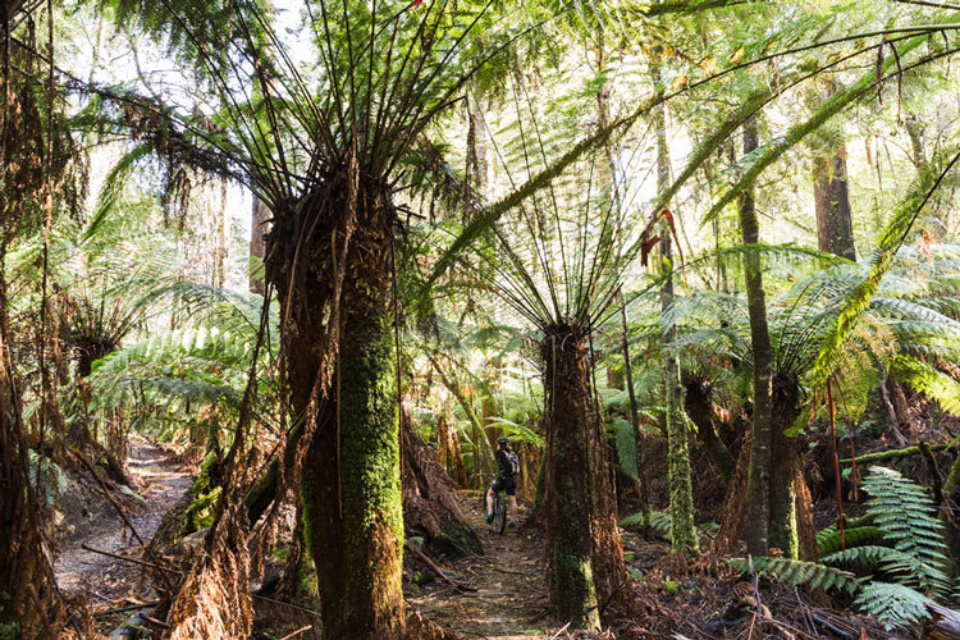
267, 177, 404, 640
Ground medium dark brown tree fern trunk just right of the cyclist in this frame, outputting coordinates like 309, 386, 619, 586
542, 326, 600, 631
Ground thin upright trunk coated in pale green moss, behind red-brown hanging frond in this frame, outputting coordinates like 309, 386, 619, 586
653, 65, 699, 552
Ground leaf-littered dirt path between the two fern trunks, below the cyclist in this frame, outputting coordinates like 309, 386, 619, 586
407, 495, 556, 640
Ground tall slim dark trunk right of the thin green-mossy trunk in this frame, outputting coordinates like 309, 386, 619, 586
738, 120, 773, 556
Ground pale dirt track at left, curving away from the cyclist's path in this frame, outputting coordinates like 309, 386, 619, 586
54, 435, 193, 609
